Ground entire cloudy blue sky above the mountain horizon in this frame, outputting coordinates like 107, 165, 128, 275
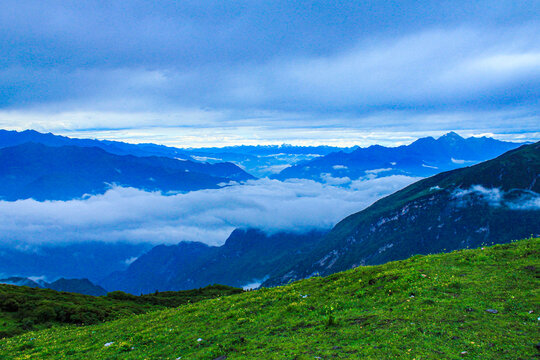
0, 0, 540, 147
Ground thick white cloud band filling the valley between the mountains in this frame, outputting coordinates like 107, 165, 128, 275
0, 176, 417, 247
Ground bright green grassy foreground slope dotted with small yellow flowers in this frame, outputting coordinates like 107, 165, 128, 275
0, 238, 540, 360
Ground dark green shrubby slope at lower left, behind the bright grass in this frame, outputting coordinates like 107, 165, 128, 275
0, 285, 242, 338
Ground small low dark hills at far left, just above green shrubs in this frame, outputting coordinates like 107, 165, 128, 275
0, 277, 107, 296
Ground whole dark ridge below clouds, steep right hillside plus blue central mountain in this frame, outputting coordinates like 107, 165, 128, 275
102, 143, 540, 294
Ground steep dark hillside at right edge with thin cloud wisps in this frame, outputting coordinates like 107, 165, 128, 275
263, 143, 540, 286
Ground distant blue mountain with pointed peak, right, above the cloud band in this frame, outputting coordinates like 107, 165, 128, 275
273, 132, 521, 181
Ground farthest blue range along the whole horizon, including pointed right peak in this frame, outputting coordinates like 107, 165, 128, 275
0, 130, 520, 184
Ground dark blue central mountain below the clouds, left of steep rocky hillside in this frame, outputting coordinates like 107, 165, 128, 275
100, 229, 324, 295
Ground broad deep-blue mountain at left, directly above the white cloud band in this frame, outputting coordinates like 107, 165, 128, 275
0, 143, 253, 200
